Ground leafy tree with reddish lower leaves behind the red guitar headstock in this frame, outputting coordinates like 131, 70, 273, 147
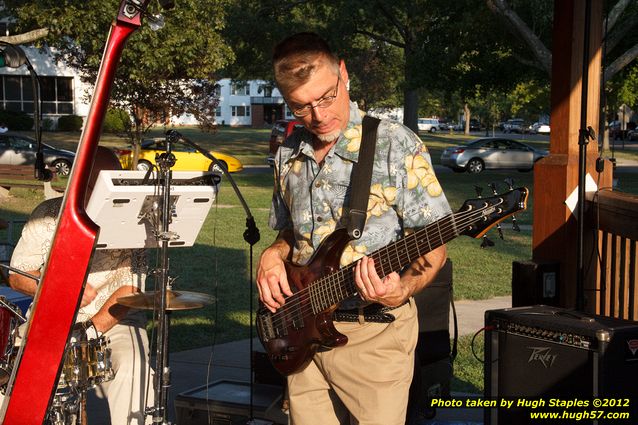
4, 0, 233, 164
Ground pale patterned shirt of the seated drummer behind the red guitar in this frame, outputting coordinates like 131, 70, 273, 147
11, 198, 146, 322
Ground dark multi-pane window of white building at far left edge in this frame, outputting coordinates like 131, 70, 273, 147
0, 75, 73, 115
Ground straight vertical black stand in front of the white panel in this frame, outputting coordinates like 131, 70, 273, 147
152, 138, 175, 424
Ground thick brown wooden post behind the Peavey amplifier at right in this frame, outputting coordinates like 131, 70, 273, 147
532, 0, 612, 311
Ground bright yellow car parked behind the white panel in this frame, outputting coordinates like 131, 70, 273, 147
116, 138, 244, 173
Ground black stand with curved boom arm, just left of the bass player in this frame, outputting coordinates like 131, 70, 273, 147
166, 130, 259, 424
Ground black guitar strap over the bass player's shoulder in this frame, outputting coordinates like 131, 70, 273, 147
348, 115, 380, 239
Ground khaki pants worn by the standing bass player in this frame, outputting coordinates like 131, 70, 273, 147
288, 300, 419, 425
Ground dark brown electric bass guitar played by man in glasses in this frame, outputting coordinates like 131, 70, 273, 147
256, 188, 528, 375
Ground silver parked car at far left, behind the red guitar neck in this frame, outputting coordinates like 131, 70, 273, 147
0, 133, 75, 176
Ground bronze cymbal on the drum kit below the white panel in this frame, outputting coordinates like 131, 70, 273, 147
117, 289, 213, 310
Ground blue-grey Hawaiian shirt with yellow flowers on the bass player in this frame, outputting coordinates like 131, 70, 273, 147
269, 102, 451, 266
